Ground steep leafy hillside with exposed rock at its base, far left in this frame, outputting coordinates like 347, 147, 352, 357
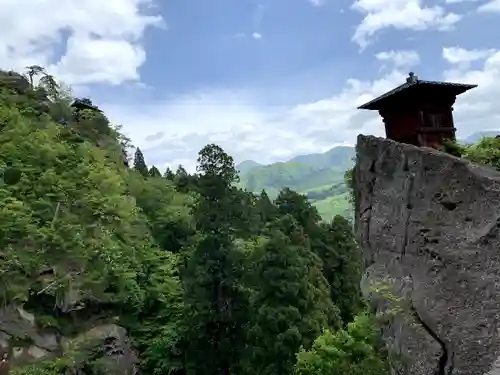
0, 68, 178, 375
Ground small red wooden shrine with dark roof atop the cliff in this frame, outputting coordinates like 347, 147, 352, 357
358, 73, 477, 148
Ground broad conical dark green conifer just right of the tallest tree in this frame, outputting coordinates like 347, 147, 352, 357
250, 215, 339, 375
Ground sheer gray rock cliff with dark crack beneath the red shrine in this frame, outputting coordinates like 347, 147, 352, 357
354, 136, 500, 375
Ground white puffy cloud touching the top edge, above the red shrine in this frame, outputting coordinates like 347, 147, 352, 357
352, 0, 461, 47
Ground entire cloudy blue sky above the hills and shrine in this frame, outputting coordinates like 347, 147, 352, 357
0, 0, 500, 169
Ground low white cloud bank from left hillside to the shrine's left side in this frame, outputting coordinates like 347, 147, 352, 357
102, 71, 406, 170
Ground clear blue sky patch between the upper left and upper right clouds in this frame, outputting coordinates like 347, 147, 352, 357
142, 0, 357, 98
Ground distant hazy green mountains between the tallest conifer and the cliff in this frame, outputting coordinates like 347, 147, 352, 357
236, 146, 355, 220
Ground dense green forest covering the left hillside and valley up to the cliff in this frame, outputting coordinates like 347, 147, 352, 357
0, 68, 385, 375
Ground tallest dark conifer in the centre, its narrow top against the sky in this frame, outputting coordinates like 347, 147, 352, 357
183, 145, 248, 375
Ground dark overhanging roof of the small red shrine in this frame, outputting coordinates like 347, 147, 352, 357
358, 72, 477, 110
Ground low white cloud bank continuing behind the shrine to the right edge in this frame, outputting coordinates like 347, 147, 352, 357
103, 47, 500, 170
